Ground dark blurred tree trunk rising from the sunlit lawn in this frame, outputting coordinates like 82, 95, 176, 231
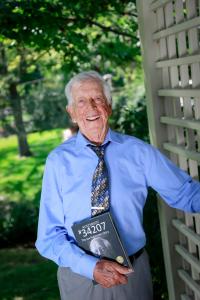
9, 83, 32, 156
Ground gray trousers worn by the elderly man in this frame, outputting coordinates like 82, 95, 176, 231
57, 251, 153, 300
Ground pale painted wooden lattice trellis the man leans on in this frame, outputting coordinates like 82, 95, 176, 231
137, 0, 200, 300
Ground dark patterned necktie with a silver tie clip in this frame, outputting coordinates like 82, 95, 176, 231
88, 143, 110, 216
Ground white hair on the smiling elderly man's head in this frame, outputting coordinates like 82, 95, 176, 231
65, 71, 112, 105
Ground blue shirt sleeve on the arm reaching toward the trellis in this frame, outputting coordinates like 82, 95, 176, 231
145, 145, 200, 213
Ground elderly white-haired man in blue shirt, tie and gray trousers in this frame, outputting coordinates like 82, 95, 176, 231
36, 71, 200, 300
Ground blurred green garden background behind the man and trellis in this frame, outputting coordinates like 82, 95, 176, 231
0, 0, 167, 300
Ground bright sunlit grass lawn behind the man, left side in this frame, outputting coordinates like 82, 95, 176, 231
0, 129, 62, 203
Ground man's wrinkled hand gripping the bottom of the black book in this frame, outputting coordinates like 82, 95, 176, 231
94, 259, 133, 288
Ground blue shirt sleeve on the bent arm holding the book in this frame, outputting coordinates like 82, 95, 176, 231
35, 157, 98, 279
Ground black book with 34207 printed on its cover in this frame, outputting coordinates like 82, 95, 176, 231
72, 212, 132, 269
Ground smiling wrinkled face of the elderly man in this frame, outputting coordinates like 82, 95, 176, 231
67, 80, 112, 145
